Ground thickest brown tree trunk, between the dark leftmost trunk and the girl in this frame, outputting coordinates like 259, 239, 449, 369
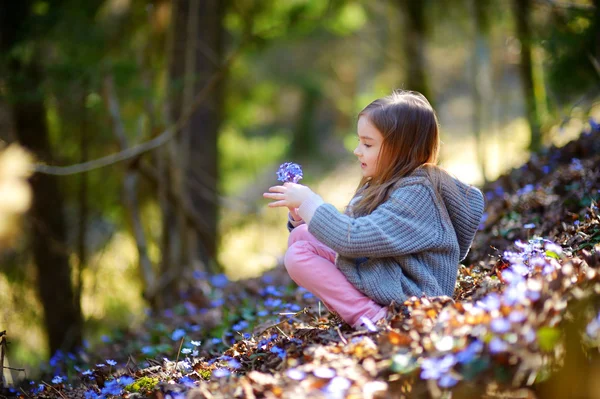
158, 0, 224, 306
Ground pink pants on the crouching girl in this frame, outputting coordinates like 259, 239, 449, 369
284, 224, 387, 327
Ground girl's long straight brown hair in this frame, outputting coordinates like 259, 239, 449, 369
352, 90, 440, 216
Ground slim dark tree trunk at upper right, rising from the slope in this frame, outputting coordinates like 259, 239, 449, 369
514, 0, 543, 151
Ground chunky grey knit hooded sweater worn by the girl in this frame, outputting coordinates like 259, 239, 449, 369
296, 169, 484, 305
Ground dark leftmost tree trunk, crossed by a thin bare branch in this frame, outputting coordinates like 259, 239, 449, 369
8, 57, 83, 354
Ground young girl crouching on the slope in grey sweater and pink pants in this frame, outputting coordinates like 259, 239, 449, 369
264, 91, 484, 327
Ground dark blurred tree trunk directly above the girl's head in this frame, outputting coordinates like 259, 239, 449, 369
398, 0, 433, 105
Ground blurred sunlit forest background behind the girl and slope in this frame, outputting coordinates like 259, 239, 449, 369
0, 0, 600, 376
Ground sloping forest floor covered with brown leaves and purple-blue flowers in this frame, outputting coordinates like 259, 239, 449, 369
0, 126, 600, 399
